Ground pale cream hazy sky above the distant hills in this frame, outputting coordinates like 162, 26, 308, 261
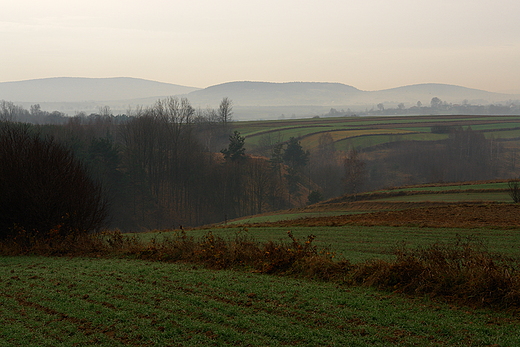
0, 0, 520, 93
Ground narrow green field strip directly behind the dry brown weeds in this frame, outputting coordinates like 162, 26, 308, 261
136, 226, 520, 263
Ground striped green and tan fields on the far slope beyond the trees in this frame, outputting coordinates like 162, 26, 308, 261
235, 116, 520, 150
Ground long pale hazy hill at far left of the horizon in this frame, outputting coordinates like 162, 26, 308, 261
0, 77, 198, 103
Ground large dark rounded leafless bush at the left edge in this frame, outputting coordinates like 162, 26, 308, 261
0, 122, 108, 243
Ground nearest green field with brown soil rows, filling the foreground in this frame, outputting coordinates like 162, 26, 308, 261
0, 256, 520, 346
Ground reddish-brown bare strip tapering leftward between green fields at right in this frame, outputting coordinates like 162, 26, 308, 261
254, 204, 520, 229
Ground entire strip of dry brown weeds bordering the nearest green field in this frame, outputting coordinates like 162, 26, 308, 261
4, 230, 520, 308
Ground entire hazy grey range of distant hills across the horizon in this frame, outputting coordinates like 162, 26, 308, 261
0, 77, 520, 120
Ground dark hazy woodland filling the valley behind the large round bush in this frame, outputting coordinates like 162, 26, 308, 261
0, 97, 515, 231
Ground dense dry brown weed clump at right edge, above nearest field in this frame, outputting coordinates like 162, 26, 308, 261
349, 239, 520, 308
